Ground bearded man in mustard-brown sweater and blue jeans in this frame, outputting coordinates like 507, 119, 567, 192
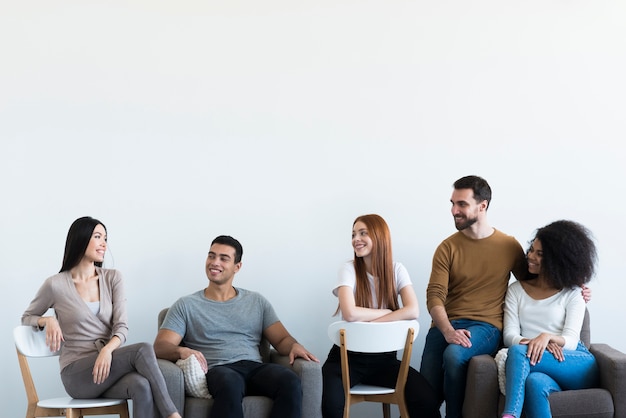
420, 176, 527, 418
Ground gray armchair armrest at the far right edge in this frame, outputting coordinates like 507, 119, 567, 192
589, 344, 626, 418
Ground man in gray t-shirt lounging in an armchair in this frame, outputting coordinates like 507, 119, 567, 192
154, 235, 319, 418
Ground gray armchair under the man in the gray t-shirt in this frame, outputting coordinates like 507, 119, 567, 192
158, 308, 322, 418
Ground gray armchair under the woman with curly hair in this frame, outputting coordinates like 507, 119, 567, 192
463, 312, 626, 418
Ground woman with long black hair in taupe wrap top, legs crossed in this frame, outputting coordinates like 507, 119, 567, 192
22, 217, 181, 418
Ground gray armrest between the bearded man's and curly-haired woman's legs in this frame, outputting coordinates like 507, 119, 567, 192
463, 354, 500, 418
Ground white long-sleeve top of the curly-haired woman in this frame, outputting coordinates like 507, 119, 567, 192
503, 281, 585, 350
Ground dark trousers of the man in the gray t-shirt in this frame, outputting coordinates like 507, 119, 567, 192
207, 360, 302, 418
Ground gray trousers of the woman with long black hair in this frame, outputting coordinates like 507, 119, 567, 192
61, 343, 176, 418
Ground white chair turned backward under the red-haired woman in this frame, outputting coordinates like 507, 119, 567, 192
328, 320, 419, 418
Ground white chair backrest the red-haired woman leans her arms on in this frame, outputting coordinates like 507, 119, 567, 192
328, 320, 419, 353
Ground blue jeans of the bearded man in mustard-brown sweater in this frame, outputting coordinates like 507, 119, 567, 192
420, 319, 502, 418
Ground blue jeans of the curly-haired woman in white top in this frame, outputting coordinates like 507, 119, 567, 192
503, 342, 600, 418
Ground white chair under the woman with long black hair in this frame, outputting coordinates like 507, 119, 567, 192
13, 325, 129, 418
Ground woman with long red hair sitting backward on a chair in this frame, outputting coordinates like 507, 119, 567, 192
322, 214, 440, 418
